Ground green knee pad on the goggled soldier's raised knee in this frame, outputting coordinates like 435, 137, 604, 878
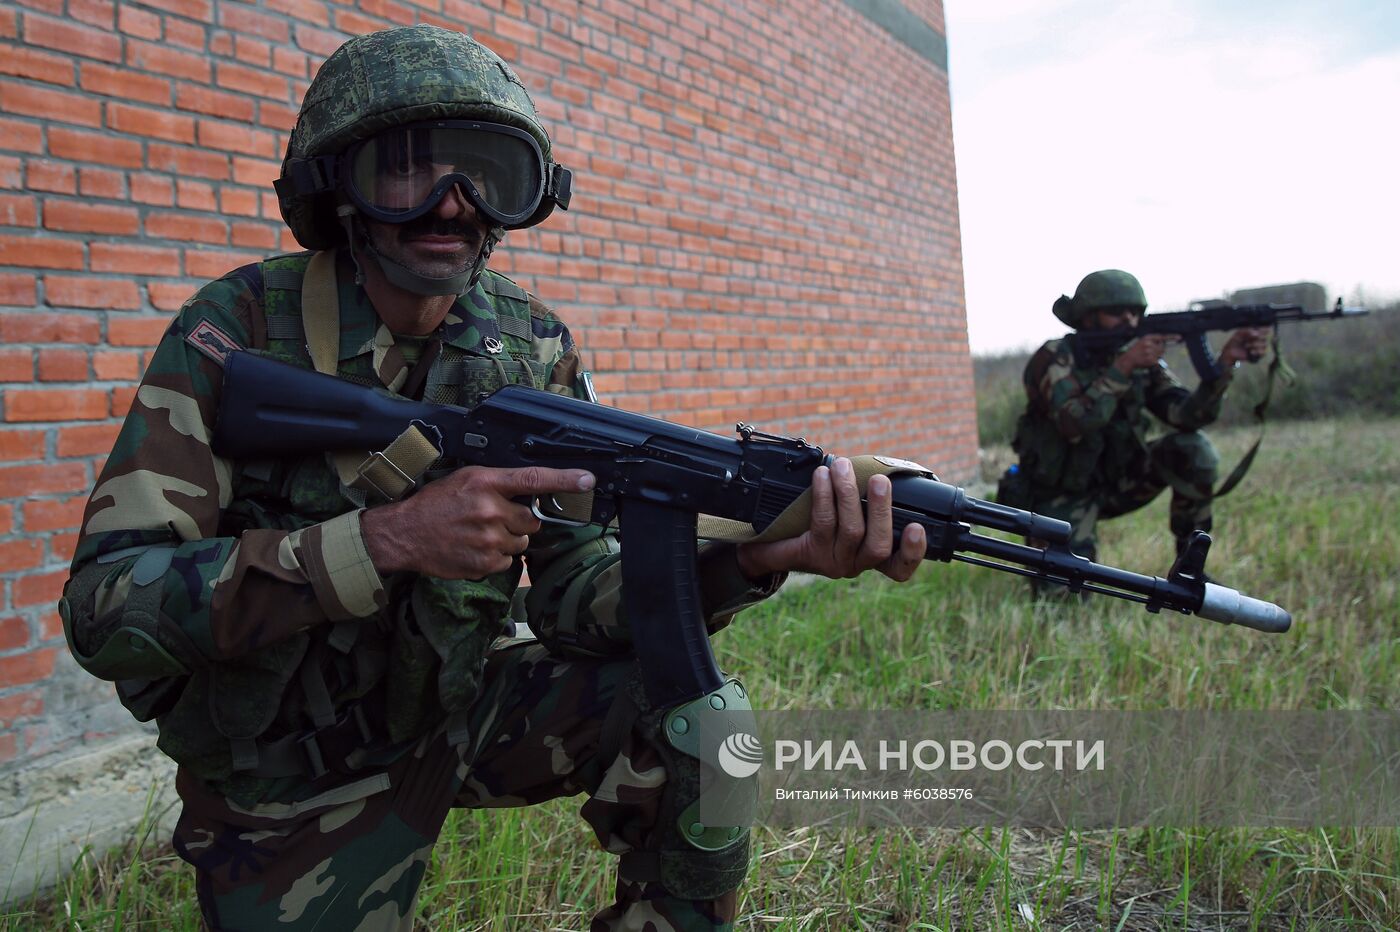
623, 677, 762, 900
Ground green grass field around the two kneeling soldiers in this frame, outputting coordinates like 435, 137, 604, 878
0, 420, 1400, 932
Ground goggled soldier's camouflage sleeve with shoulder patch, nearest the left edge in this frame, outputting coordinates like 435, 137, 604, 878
63, 270, 385, 676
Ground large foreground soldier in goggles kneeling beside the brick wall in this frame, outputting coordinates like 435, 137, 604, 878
60, 27, 924, 931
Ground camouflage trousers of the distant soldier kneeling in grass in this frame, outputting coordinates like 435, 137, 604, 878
1032, 431, 1219, 561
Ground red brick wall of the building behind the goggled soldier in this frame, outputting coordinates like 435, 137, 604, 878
0, 0, 976, 767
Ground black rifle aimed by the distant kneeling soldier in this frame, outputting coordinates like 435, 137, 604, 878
1070, 298, 1366, 381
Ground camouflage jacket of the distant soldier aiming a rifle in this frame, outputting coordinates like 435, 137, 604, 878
1012, 336, 1232, 495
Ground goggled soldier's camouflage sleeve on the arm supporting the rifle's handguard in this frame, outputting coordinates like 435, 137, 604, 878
525, 312, 785, 655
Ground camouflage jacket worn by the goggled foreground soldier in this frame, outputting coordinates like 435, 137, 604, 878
60, 253, 780, 802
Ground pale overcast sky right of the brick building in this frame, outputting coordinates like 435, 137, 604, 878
945, 0, 1400, 354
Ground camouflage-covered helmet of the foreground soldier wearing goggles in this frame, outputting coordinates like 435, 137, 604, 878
274, 25, 567, 249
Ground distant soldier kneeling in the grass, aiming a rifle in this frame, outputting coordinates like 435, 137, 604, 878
997, 269, 1268, 560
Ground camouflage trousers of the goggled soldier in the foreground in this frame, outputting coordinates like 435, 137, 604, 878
175, 644, 738, 932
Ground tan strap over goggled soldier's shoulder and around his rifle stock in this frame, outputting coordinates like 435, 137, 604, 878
301, 249, 442, 492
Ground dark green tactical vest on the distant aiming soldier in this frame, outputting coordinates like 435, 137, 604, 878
1011, 341, 1151, 501
